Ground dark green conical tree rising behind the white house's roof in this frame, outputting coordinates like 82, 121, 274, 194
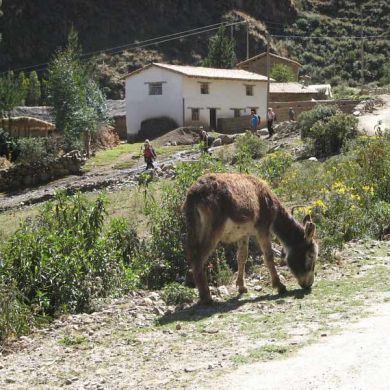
203, 26, 237, 69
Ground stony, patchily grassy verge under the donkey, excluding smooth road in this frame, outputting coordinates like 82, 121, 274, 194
0, 241, 390, 389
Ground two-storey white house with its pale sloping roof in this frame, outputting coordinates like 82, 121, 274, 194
126, 63, 267, 138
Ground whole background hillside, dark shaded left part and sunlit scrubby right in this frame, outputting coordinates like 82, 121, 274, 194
0, 0, 390, 99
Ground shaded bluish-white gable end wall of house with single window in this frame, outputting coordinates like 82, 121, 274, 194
126, 66, 183, 137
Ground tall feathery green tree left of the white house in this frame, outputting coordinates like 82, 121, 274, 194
48, 30, 107, 156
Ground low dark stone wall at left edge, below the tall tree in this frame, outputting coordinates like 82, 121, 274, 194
0, 150, 86, 191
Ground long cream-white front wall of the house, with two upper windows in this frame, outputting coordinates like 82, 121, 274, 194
183, 77, 267, 126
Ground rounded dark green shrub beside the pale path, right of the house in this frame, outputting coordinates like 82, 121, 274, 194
307, 114, 358, 157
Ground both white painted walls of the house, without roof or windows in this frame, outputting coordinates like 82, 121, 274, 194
126, 66, 267, 137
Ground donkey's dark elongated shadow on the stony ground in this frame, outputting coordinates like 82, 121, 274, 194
157, 289, 311, 325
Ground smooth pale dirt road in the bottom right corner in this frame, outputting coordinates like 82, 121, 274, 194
202, 304, 390, 390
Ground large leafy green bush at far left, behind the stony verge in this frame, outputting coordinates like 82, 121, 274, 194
2, 194, 128, 315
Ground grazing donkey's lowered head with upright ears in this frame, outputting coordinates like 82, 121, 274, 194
287, 215, 318, 288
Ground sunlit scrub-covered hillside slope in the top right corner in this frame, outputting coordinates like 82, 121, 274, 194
280, 0, 390, 85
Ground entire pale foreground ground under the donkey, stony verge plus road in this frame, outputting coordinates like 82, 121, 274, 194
0, 241, 390, 390
